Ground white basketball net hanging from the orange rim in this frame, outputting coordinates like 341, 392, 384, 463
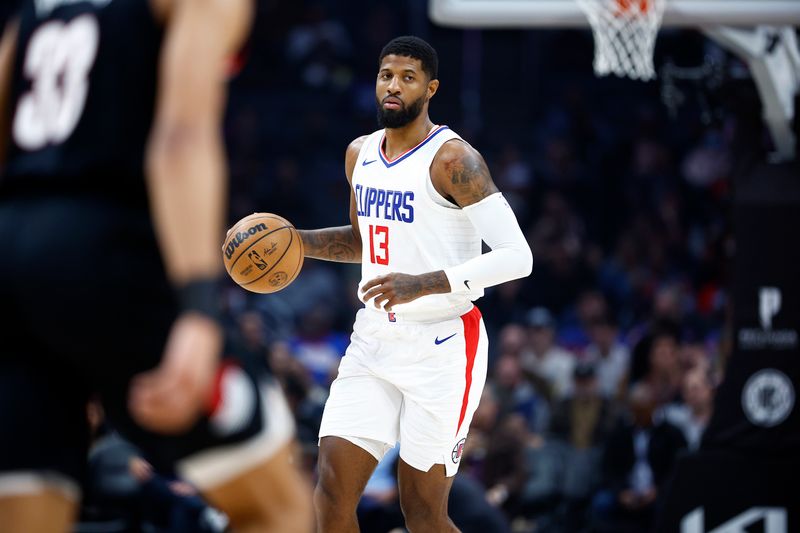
576, 0, 667, 80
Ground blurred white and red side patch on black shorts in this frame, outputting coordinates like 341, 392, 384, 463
209, 365, 258, 436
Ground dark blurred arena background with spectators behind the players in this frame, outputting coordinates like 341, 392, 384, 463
0, 0, 800, 533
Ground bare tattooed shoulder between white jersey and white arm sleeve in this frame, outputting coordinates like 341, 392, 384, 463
431, 139, 498, 207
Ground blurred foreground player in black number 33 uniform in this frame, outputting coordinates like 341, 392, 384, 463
0, 0, 311, 532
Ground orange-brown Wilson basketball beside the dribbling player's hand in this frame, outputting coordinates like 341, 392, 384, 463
222, 213, 303, 294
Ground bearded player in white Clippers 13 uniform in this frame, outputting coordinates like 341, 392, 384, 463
300, 37, 533, 533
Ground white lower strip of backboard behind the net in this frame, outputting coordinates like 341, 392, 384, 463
429, 0, 800, 28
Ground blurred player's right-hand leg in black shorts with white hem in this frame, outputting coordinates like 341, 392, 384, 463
107, 368, 313, 533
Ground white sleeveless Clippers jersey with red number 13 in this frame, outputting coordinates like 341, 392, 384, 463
352, 126, 483, 321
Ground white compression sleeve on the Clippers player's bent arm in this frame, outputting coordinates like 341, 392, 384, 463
444, 192, 533, 293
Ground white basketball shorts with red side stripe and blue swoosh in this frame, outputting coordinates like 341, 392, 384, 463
319, 307, 488, 477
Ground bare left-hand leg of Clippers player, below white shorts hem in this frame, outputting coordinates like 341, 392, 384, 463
314, 437, 383, 533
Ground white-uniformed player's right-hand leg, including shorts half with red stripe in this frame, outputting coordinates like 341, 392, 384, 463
398, 308, 488, 533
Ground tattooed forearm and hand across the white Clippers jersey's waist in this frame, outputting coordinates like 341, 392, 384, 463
361, 270, 450, 311
